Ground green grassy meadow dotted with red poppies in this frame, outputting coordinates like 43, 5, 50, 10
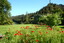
0, 24, 64, 43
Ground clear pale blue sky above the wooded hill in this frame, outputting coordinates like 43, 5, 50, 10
8, 0, 64, 16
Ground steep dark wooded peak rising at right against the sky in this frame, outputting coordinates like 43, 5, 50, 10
36, 3, 64, 14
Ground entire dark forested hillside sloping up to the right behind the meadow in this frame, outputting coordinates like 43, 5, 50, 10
12, 3, 64, 24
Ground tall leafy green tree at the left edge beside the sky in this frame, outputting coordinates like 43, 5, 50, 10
0, 0, 12, 25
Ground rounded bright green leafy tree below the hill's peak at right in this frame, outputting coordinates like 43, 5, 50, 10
39, 13, 62, 26
